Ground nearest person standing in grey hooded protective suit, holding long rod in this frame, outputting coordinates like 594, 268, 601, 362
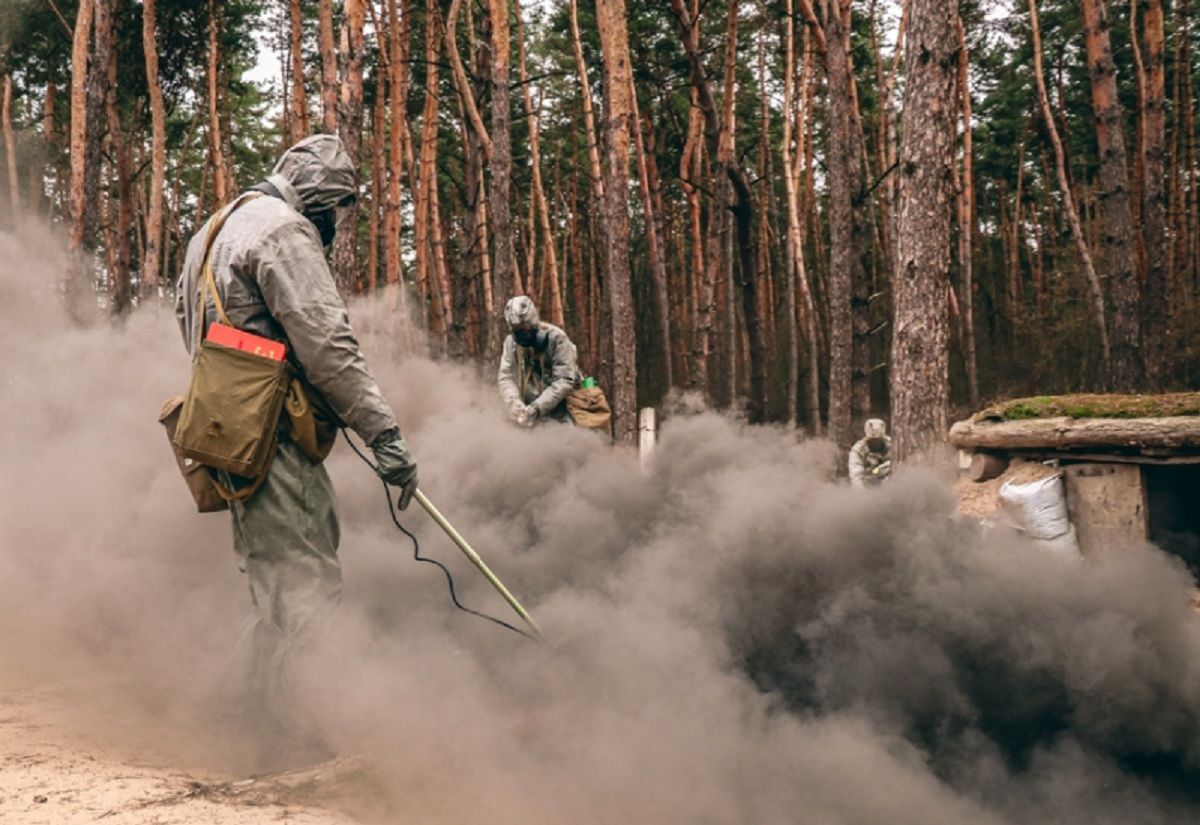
175, 134, 416, 748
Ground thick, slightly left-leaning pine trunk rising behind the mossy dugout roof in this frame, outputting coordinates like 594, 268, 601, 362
1080, 0, 1142, 392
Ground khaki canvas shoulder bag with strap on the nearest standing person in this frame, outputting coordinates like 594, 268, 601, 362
173, 193, 290, 499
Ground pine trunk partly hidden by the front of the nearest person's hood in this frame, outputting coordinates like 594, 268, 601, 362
332, 0, 366, 296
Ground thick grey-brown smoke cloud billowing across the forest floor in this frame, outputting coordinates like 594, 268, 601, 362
0, 221, 1200, 825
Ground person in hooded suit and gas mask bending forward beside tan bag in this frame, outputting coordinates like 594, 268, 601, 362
497, 295, 581, 427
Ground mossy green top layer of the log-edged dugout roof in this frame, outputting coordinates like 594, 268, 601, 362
972, 392, 1200, 422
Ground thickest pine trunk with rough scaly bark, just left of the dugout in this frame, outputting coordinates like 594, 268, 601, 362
890, 0, 959, 460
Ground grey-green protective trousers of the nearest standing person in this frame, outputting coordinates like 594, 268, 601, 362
230, 441, 342, 735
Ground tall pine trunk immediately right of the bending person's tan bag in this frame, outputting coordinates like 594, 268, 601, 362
596, 0, 637, 445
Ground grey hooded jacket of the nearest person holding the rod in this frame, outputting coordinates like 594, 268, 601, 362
175, 134, 397, 444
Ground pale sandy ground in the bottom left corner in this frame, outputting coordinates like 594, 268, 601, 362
0, 689, 359, 825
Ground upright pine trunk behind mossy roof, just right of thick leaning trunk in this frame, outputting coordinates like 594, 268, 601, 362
1141, 0, 1174, 391
